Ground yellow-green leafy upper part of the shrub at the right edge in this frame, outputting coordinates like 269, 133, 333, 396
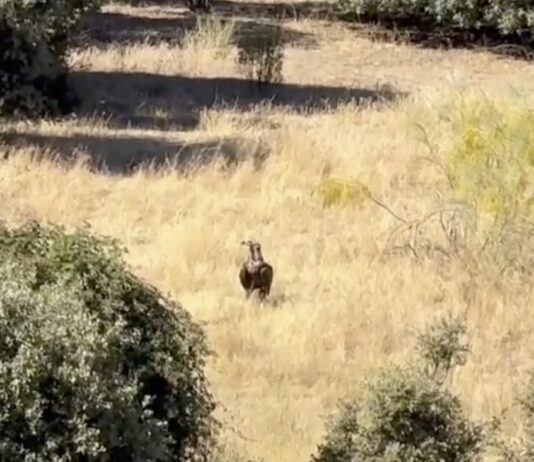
445, 94, 534, 218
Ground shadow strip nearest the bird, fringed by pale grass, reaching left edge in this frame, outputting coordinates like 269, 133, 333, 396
2, 131, 267, 175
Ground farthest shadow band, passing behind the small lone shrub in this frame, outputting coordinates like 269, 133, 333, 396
84, 10, 316, 48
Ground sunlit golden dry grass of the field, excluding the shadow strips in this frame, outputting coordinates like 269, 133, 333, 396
0, 2, 534, 462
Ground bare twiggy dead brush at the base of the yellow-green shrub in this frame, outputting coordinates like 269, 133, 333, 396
382, 198, 534, 282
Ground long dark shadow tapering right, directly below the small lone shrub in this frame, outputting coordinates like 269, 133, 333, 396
71, 71, 404, 129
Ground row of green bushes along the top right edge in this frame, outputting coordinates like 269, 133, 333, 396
338, 0, 534, 35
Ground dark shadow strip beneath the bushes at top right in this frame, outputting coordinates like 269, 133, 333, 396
340, 15, 534, 61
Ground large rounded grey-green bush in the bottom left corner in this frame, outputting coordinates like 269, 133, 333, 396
0, 224, 220, 462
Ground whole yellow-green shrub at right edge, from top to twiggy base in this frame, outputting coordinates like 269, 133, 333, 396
418, 90, 534, 282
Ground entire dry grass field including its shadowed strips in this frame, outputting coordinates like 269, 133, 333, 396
0, 2, 534, 462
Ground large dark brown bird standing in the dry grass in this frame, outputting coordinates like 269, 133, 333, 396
243, 240, 274, 300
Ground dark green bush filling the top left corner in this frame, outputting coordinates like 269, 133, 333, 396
0, 0, 103, 117
